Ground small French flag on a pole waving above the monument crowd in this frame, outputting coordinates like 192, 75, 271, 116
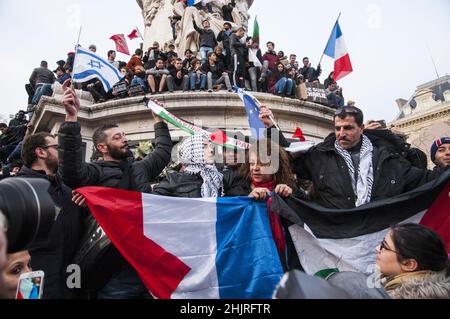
324, 19, 353, 81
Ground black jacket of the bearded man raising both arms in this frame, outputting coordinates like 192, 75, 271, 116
58, 122, 172, 193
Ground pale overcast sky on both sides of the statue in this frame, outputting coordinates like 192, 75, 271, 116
0, 0, 450, 121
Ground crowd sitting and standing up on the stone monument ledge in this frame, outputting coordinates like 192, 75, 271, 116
25, 25, 345, 109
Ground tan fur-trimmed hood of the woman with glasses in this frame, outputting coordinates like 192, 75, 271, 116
384, 271, 450, 299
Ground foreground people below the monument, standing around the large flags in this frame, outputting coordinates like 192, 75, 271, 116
0, 78, 450, 299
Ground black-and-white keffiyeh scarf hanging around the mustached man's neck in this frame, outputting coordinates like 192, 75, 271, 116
334, 135, 373, 207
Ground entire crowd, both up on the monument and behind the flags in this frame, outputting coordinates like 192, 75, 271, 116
0, 3, 450, 299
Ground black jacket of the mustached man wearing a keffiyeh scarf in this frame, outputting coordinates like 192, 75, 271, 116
294, 131, 440, 209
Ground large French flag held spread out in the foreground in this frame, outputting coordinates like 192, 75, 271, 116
77, 187, 283, 299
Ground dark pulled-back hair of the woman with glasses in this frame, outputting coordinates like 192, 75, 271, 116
391, 224, 449, 272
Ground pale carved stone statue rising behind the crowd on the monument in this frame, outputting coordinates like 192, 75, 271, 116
136, 0, 253, 56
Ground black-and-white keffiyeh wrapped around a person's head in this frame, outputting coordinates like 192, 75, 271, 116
179, 134, 223, 198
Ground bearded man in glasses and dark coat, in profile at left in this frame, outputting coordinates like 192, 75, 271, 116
16, 133, 82, 299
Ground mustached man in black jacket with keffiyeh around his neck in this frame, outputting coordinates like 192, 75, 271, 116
294, 106, 439, 209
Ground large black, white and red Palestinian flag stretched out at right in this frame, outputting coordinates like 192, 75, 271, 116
271, 170, 450, 275
